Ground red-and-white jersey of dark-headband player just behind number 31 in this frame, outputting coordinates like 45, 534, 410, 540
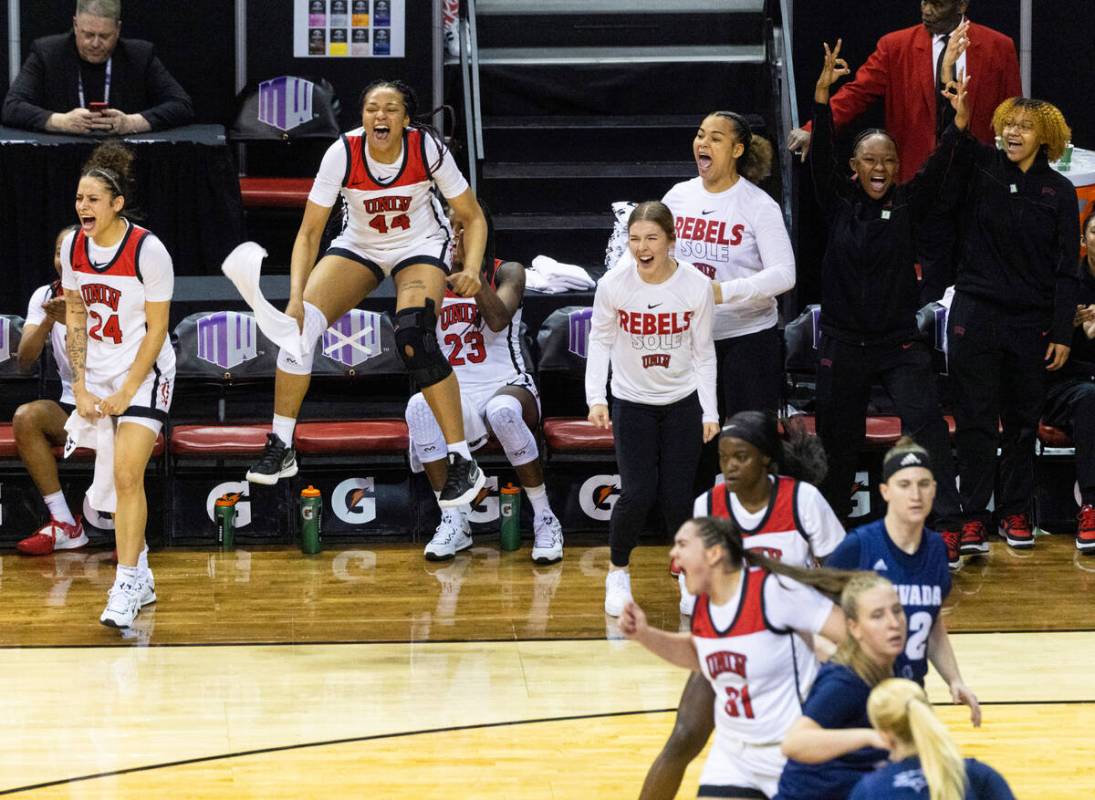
692, 475, 845, 568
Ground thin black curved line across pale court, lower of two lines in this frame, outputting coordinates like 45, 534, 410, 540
0, 700, 1095, 795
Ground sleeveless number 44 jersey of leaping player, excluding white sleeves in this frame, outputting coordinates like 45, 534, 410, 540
342, 128, 452, 251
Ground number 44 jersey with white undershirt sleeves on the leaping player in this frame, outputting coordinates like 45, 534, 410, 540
308, 127, 468, 253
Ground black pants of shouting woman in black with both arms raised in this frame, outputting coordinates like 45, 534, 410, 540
817, 334, 961, 525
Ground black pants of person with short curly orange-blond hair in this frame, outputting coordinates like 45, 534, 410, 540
947, 292, 1049, 525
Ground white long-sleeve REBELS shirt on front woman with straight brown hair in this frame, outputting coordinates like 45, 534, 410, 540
586, 262, 718, 422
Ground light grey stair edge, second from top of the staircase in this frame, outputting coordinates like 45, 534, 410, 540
446, 45, 765, 67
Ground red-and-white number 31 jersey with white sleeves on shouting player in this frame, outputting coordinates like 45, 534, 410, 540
692, 568, 832, 744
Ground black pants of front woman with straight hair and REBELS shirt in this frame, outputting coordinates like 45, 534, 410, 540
609, 392, 703, 567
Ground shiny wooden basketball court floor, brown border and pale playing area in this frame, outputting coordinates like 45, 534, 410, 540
0, 537, 1095, 799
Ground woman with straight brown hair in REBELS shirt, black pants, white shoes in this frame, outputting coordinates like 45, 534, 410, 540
586, 200, 718, 616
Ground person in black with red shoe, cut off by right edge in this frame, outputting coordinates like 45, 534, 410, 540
1042, 205, 1095, 553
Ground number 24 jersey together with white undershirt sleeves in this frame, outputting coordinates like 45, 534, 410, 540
61, 224, 175, 389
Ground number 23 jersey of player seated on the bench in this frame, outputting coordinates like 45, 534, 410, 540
437, 259, 531, 391
